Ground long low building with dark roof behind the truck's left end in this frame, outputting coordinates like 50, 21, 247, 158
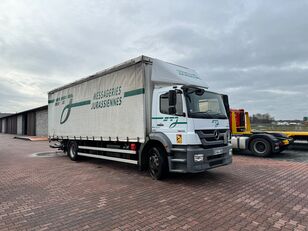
0, 105, 48, 136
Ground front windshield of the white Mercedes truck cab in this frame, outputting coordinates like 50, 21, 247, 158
185, 88, 227, 119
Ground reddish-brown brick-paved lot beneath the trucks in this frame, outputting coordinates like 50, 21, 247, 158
0, 134, 308, 230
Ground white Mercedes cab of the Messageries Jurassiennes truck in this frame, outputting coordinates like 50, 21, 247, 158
150, 85, 232, 177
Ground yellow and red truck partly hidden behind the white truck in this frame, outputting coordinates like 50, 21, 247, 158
230, 109, 293, 157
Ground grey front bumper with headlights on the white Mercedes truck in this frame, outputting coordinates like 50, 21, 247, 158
168, 144, 232, 173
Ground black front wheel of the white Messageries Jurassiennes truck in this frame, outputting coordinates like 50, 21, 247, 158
148, 147, 168, 180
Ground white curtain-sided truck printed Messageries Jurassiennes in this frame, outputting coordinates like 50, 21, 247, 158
48, 56, 232, 180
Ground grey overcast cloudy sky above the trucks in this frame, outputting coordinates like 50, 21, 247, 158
0, 0, 308, 119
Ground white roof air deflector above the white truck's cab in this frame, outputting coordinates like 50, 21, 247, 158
151, 59, 208, 88
